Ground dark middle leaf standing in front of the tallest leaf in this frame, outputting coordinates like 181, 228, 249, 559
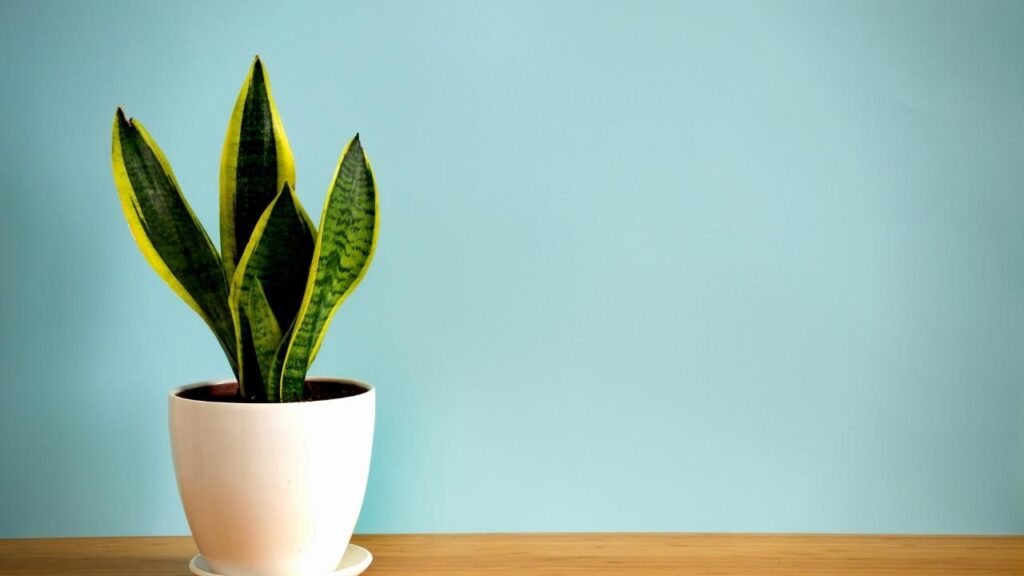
229, 183, 316, 401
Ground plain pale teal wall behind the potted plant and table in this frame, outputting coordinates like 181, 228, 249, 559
0, 0, 1024, 537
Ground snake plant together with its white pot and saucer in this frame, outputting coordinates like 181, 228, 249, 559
113, 56, 380, 576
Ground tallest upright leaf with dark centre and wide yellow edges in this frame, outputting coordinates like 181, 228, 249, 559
220, 56, 294, 278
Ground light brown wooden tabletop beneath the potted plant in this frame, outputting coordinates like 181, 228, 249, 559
0, 534, 1024, 576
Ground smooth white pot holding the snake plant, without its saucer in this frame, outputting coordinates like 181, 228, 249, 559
170, 378, 375, 576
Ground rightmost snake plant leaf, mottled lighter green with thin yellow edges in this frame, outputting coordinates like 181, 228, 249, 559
281, 134, 380, 402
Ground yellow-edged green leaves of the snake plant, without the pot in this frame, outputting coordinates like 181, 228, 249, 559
112, 56, 380, 402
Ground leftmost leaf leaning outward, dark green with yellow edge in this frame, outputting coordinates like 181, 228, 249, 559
112, 109, 238, 374
